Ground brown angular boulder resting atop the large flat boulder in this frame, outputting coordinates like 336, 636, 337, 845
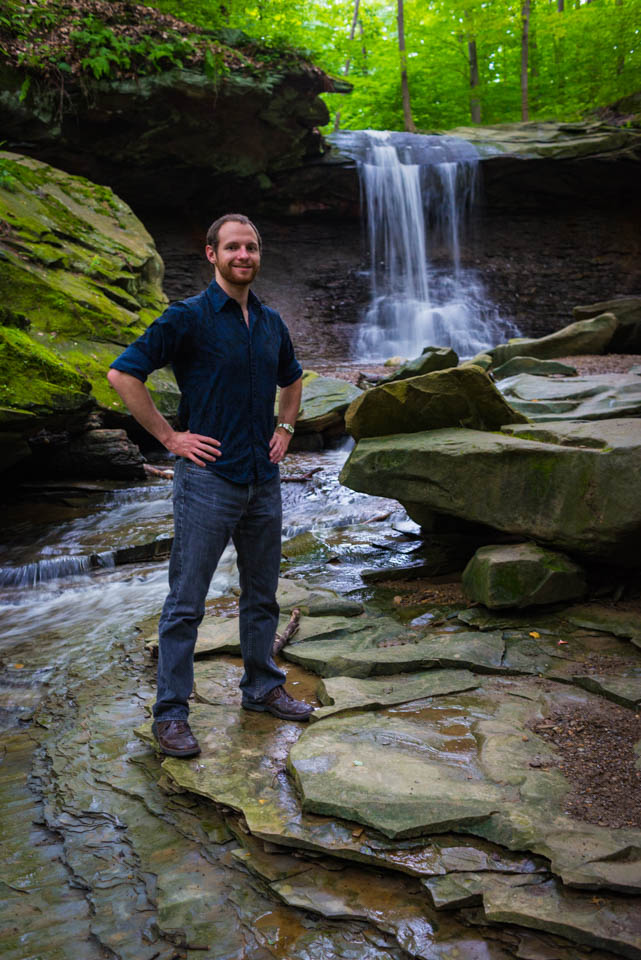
345, 367, 525, 440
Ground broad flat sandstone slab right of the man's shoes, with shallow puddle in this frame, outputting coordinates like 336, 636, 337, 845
289, 678, 641, 901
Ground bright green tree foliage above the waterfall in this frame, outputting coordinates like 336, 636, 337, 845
141, 0, 641, 131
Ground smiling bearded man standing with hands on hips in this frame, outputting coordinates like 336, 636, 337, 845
108, 214, 313, 757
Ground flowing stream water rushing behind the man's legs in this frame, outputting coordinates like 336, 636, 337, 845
0, 450, 404, 723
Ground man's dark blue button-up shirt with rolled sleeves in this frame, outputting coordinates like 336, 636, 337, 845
111, 280, 303, 483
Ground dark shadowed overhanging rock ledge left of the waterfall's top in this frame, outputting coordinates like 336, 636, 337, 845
0, 30, 338, 209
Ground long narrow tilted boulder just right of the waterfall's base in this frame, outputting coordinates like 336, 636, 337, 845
488, 313, 619, 366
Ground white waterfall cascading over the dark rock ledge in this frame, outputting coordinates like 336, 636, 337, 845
330, 130, 518, 360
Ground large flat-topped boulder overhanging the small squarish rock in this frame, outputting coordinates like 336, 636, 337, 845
340, 418, 641, 567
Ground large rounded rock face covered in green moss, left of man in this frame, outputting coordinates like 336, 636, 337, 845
0, 152, 171, 476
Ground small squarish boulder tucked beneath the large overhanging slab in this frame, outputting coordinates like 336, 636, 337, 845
463, 543, 586, 610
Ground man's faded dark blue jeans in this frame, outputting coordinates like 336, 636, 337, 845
154, 460, 285, 720
